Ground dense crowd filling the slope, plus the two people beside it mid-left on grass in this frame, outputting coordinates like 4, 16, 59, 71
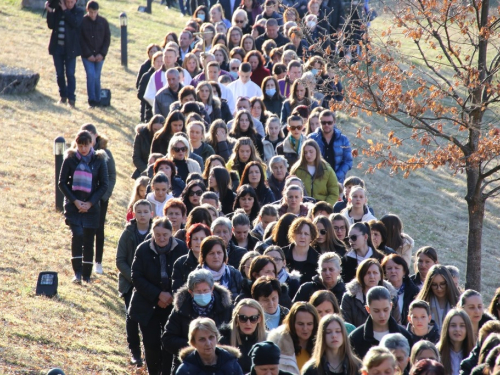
54, 0, 500, 375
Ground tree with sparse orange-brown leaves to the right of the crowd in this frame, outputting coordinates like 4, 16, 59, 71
308, 0, 500, 290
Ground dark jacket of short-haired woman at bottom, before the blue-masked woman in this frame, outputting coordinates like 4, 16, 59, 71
176, 345, 243, 375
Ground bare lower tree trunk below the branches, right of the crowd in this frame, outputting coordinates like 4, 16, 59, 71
465, 167, 485, 292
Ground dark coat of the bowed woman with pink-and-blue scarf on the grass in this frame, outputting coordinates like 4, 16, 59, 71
58, 148, 109, 228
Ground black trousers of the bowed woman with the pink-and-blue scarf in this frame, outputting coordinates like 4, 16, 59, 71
70, 224, 96, 278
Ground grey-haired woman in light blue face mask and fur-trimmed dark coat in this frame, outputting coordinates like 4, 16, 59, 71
162, 269, 233, 374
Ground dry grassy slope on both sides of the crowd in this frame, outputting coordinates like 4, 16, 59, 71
0, 0, 500, 374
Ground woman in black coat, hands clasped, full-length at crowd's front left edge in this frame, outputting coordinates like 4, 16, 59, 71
129, 217, 188, 374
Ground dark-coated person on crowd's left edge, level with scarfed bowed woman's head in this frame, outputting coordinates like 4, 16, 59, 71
132, 115, 165, 180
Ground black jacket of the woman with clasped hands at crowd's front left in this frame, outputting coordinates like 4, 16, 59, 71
129, 238, 188, 325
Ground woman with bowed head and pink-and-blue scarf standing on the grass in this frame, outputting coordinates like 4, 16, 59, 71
59, 130, 108, 284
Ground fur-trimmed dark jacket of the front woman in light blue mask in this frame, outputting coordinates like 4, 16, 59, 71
162, 284, 233, 355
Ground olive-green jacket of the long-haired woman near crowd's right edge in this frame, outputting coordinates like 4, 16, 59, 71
295, 161, 339, 206
